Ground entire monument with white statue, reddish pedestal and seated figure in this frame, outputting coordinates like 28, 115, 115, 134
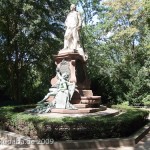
34, 4, 104, 113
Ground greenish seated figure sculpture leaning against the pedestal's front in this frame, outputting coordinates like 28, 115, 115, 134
32, 69, 77, 113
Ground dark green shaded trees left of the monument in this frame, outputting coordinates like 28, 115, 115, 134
0, 0, 69, 103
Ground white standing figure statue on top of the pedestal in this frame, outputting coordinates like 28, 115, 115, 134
59, 4, 87, 61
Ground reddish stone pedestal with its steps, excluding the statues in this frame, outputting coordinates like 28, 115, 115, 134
49, 53, 104, 113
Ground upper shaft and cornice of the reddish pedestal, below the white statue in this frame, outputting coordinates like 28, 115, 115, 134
54, 53, 90, 89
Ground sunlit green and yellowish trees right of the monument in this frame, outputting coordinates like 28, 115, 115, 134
80, 0, 150, 105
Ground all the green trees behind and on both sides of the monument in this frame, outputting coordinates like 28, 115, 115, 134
0, 0, 150, 105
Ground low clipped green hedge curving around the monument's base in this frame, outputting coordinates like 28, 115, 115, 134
0, 106, 149, 141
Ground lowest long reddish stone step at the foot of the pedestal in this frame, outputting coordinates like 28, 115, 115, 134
51, 108, 100, 114
